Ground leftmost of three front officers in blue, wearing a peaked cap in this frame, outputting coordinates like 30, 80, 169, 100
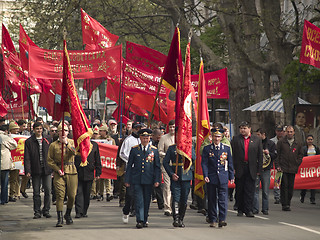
125, 129, 161, 228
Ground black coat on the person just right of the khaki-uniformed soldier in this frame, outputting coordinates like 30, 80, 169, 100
75, 141, 101, 181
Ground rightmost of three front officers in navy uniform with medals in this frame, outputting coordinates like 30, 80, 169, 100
201, 128, 234, 227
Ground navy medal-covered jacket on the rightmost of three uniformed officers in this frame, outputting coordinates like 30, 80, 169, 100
201, 143, 234, 185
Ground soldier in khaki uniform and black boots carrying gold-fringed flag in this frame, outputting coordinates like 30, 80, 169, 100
48, 124, 78, 227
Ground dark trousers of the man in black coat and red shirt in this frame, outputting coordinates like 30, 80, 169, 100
236, 164, 255, 213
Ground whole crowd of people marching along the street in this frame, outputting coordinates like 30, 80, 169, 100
0, 115, 320, 229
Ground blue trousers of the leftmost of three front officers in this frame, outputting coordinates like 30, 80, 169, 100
133, 184, 152, 223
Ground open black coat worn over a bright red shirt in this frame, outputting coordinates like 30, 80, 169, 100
231, 134, 263, 179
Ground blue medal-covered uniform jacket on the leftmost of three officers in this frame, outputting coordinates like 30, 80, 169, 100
125, 144, 161, 184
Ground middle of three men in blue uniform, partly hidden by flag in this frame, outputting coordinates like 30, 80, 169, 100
163, 127, 196, 227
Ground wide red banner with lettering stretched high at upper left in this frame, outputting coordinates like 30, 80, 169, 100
29, 45, 122, 79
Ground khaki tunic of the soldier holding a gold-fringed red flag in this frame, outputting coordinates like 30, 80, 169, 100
47, 139, 77, 174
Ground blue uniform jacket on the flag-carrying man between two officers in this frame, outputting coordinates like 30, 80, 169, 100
163, 144, 195, 181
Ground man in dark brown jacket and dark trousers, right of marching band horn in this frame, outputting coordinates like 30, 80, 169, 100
275, 126, 303, 211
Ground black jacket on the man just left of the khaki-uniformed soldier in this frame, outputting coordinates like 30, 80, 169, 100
24, 134, 52, 176
